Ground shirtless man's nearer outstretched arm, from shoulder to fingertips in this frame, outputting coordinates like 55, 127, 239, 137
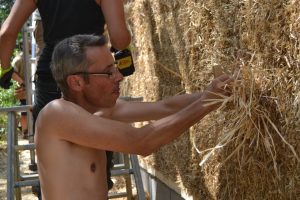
37, 76, 230, 155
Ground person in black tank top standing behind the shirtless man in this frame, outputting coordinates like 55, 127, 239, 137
0, 0, 131, 195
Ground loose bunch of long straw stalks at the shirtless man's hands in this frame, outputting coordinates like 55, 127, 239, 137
194, 66, 300, 175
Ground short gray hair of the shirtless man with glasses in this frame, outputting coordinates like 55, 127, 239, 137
51, 35, 106, 95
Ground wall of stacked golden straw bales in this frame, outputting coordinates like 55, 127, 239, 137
123, 0, 300, 199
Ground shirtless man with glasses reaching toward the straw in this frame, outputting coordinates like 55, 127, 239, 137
35, 35, 232, 200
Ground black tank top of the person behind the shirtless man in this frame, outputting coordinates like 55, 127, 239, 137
37, 0, 105, 73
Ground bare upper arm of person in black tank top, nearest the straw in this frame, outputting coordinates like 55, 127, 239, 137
100, 0, 131, 50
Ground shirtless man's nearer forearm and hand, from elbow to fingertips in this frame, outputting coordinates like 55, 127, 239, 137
141, 74, 233, 155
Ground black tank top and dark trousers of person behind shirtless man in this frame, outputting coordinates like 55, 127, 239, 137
33, 0, 113, 189
